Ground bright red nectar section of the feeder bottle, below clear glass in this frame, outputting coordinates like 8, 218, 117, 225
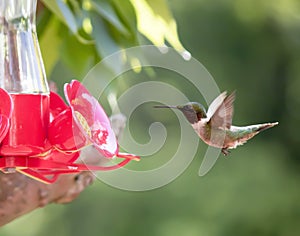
0, 94, 49, 156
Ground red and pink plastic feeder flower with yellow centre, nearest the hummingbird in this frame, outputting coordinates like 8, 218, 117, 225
49, 80, 139, 161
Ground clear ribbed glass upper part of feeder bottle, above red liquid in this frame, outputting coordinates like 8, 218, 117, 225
0, 0, 49, 94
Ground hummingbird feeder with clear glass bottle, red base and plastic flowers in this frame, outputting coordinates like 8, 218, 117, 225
0, 0, 139, 183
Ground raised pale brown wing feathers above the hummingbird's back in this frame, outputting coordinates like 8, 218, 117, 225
207, 91, 235, 129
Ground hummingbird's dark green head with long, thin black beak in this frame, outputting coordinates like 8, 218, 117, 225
155, 102, 207, 124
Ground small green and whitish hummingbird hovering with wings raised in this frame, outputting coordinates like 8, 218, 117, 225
154, 91, 278, 156
